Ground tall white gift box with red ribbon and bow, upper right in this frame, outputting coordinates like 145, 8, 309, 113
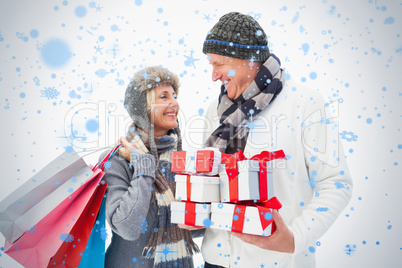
219, 150, 285, 203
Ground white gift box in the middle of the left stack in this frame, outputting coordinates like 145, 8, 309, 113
175, 174, 220, 203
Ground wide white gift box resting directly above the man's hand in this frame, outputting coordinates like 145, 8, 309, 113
210, 203, 272, 236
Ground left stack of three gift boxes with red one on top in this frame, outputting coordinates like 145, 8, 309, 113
171, 148, 229, 227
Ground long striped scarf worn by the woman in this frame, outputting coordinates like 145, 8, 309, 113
127, 125, 199, 268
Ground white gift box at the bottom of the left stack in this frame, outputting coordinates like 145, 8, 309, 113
170, 202, 211, 227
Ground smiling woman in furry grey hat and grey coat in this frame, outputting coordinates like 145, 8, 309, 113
104, 67, 198, 268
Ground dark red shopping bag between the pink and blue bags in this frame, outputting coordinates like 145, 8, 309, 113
48, 183, 107, 268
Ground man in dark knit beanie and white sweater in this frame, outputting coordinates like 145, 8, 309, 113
202, 12, 352, 268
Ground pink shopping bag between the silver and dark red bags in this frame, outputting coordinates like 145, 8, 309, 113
4, 169, 104, 268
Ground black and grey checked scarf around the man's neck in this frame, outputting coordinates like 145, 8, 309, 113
205, 54, 285, 153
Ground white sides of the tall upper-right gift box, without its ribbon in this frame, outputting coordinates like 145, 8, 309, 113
219, 160, 274, 202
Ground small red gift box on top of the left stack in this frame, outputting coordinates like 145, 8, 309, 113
172, 147, 229, 175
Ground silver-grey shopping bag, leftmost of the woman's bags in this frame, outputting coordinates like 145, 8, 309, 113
0, 152, 94, 243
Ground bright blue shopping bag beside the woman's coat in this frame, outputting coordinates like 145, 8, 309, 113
78, 196, 107, 268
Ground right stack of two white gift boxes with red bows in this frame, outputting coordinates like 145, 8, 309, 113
210, 150, 285, 236
